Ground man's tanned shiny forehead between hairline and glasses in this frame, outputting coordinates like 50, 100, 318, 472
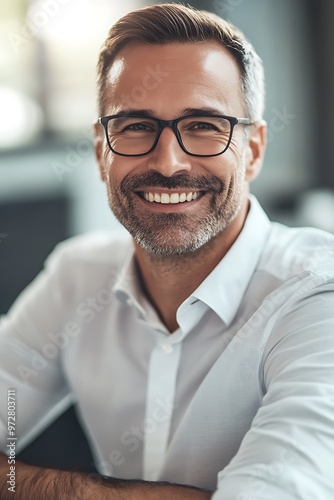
105, 42, 244, 119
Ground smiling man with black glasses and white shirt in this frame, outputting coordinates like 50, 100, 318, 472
0, 4, 334, 500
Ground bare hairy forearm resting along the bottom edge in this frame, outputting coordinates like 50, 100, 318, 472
0, 455, 212, 500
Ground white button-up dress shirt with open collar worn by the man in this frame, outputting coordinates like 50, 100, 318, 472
0, 197, 334, 500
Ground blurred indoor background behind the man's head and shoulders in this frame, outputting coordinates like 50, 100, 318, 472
0, 0, 334, 470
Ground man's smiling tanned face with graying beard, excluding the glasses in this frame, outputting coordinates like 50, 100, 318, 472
96, 42, 260, 255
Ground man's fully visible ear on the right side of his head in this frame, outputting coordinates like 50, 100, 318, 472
246, 120, 267, 182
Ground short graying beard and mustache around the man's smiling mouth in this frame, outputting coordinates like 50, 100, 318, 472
108, 169, 244, 257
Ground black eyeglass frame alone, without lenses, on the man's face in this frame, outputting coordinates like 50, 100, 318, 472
97, 113, 255, 158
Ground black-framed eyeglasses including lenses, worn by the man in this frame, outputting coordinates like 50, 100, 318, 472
98, 113, 253, 156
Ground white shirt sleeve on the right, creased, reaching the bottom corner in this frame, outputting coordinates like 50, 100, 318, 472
212, 281, 334, 500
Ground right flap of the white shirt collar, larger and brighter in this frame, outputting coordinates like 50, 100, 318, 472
180, 195, 271, 325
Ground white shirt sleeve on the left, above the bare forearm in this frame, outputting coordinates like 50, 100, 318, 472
0, 244, 71, 453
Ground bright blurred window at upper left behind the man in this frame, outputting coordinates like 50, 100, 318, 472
0, 0, 142, 149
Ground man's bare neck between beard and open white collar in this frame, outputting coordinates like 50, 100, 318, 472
135, 196, 248, 332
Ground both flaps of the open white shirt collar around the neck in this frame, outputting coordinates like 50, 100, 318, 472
113, 195, 271, 325
